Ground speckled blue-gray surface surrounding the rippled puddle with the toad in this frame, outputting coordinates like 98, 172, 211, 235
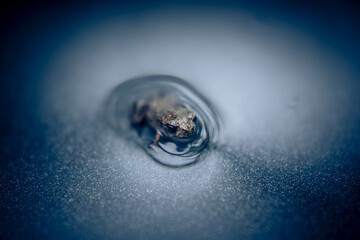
0, 1, 360, 239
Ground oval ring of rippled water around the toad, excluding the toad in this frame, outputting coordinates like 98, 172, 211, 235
106, 75, 221, 167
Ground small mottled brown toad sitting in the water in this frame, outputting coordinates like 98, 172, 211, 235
130, 96, 196, 144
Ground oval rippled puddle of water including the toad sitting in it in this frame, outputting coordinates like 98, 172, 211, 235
106, 75, 221, 167
